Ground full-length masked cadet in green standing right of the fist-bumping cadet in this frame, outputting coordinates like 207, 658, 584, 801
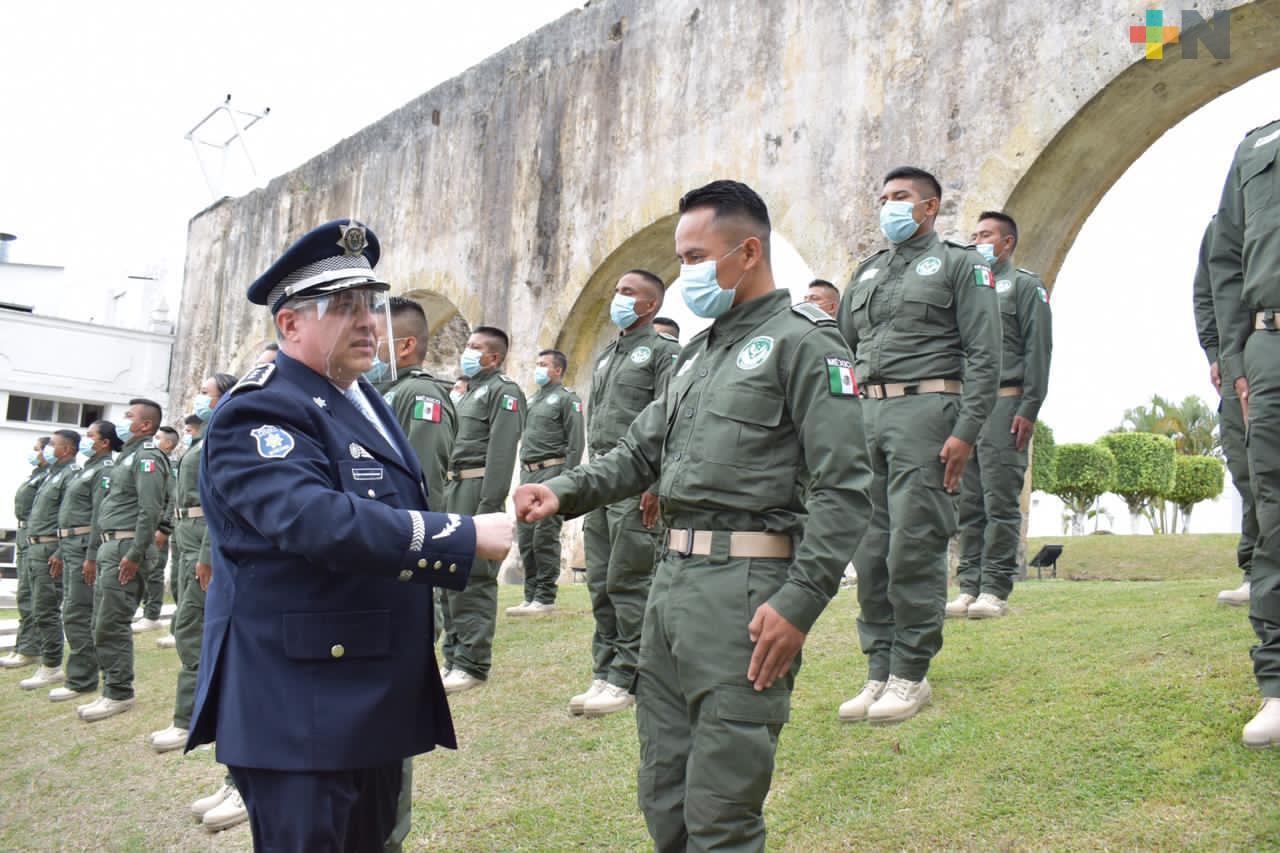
838, 167, 1000, 724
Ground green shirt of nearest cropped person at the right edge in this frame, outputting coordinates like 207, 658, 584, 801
1208, 120, 1280, 386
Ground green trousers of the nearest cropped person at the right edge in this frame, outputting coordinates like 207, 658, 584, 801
1244, 332, 1280, 698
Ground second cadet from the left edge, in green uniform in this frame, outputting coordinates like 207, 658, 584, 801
19, 429, 79, 690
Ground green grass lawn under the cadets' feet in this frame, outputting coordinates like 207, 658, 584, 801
0, 535, 1280, 850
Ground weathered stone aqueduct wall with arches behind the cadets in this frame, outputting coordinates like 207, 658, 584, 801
170, 0, 1280, 403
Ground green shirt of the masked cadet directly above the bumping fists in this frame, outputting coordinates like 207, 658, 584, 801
449, 370, 526, 512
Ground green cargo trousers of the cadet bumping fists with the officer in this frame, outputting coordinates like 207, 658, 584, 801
636, 548, 800, 852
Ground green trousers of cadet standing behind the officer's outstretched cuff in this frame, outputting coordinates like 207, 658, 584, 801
443, 476, 502, 680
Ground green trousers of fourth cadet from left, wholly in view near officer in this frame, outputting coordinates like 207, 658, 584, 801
93, 539, 155, 699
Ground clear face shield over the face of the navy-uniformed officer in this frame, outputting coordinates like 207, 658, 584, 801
280, 287, 396, 388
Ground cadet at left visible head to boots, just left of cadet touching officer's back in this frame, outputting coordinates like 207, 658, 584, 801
77, 398, 170, 722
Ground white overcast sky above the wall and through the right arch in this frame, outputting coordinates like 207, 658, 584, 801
0, 0, 1280, 529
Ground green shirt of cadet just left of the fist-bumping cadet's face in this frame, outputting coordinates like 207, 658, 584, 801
586, 324, 680, 456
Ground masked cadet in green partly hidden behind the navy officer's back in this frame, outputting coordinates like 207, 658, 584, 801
151, 373, 236, 752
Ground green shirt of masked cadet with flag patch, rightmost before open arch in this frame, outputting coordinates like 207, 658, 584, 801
991, 261, 1053, 420
